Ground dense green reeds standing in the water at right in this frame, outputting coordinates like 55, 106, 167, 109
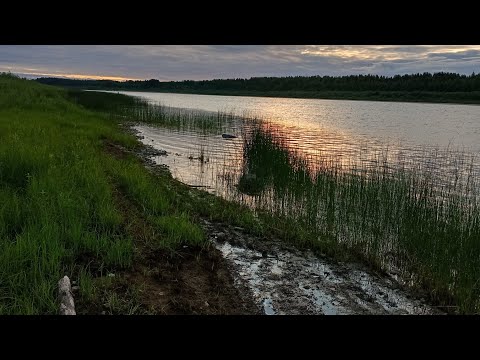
230, 124, 480, 312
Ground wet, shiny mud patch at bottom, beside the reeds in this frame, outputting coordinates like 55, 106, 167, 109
119, 124, 442, 315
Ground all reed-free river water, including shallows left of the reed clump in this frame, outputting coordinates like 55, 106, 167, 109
118, 92, 480, 206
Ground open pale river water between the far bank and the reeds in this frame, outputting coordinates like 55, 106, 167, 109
123, 92, 480, 153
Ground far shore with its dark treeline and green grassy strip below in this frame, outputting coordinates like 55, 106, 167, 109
37, 72, 480, 103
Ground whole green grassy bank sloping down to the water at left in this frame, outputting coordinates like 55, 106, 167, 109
0, 75, 258, 314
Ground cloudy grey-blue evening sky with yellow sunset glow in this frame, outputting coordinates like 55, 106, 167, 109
0, 45, 480, 81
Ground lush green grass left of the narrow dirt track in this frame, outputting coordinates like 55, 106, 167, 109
0, 76, 132, 314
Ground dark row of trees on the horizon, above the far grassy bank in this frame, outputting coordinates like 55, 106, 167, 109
37, 72, 480, 92
